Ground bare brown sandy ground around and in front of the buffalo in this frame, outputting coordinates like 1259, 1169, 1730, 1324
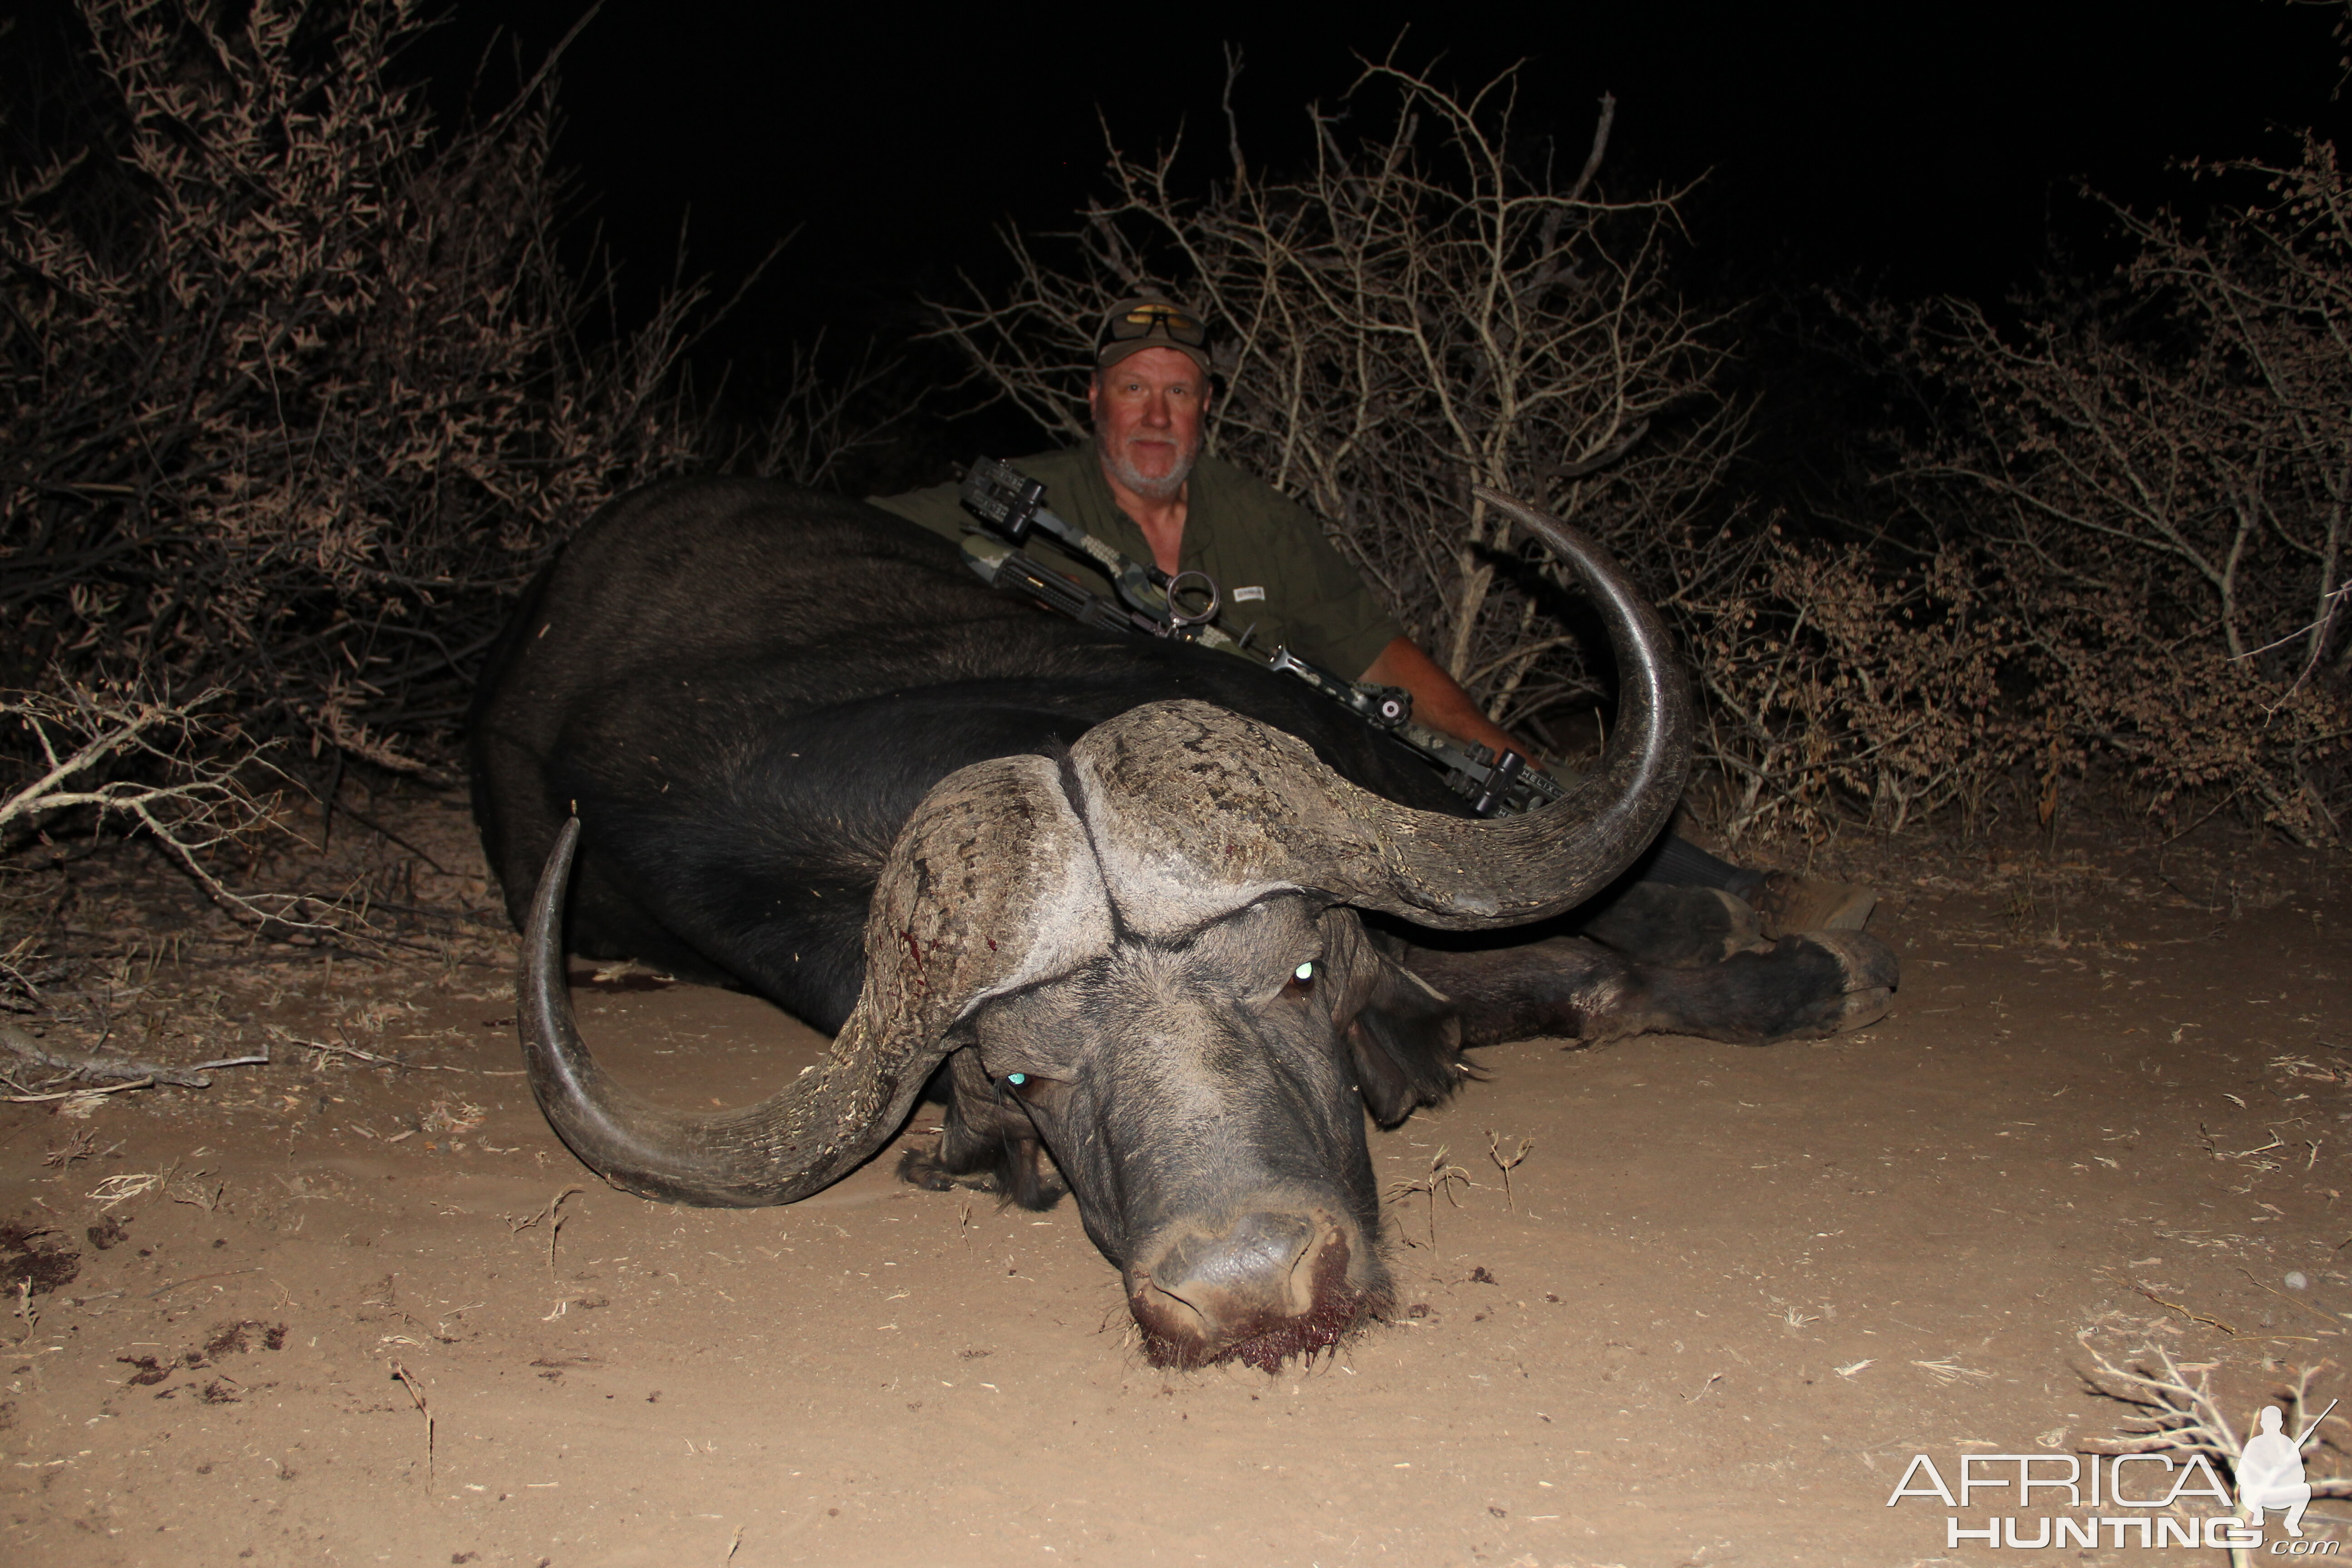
0, 804, 2352, 1568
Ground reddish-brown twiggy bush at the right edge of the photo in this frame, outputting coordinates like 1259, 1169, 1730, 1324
1903, 139, 2352, 844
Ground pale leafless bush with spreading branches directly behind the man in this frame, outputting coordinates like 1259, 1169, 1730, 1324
938, 61, 1743, 747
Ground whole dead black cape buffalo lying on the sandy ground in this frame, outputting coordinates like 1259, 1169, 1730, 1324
470, 480, 1893, 1368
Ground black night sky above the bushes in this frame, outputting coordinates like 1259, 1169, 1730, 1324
419, 0, 2345, 416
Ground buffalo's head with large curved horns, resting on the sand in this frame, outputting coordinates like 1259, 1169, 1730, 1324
522, 496, 1689, 1368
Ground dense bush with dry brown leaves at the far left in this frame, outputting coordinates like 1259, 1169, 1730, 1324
0, 0, 701, 769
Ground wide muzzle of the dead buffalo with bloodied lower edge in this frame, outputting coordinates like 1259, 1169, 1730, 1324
1127, 1213, 1381, 1373
